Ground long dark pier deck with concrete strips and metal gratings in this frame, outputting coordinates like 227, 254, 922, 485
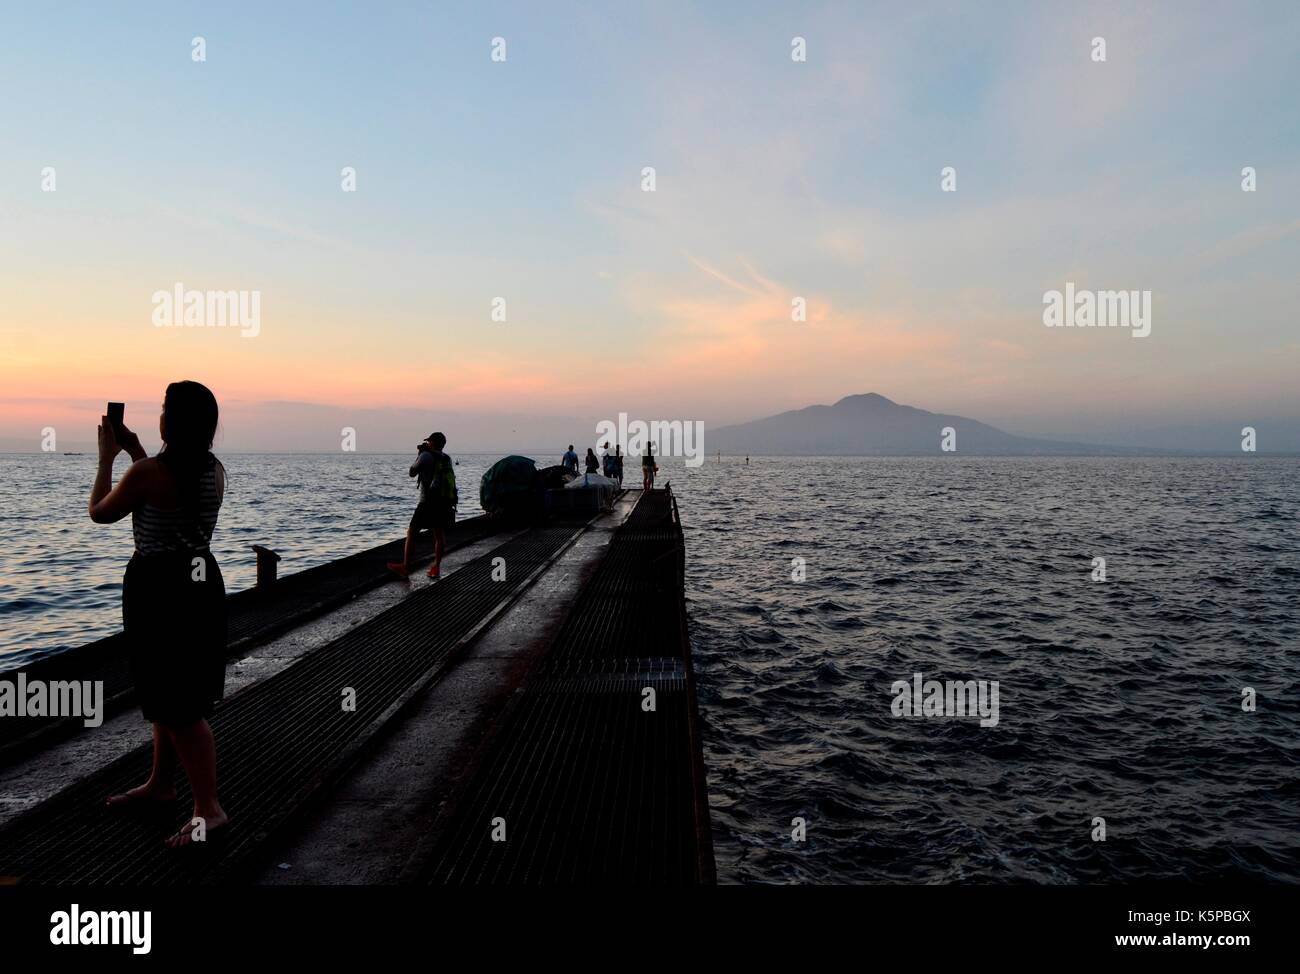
0, 492, 712, 886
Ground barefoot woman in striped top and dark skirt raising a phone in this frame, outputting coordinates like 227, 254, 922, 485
90, 381, 230, 848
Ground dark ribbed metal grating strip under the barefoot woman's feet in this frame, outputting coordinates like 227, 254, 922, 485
0, 523, 584, 886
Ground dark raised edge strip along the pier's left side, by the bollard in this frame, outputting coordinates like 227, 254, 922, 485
0, 516, 497, 767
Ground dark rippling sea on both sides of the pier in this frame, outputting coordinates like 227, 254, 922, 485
0, 453, 1300, 883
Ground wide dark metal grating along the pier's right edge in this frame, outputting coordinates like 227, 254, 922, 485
412, 490, 714, 884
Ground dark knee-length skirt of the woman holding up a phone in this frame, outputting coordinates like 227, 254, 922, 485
122, 551, 226, 728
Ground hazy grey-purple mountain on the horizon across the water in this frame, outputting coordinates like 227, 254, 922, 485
707, 393, 1153, 456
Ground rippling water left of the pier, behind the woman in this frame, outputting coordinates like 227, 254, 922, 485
0, 454, 501, 666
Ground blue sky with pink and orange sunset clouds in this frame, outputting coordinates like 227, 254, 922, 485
0, 1, 1300, 450
